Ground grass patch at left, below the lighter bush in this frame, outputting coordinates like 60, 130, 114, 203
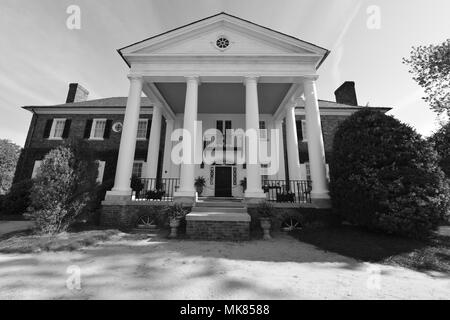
0, 230, 130, 253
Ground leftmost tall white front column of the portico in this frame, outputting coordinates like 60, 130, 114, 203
107, 75, 142, 198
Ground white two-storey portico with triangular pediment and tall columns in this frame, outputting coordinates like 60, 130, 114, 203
106, 13, 329, 207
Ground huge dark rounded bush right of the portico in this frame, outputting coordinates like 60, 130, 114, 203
330, 109, 450, 237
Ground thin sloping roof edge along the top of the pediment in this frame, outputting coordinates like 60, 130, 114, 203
117, 11, 331, 69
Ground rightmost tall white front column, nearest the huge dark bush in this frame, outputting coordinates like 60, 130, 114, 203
303, 79, 330, 201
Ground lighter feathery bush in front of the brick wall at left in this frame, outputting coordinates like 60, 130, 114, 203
28, 141, 97, 234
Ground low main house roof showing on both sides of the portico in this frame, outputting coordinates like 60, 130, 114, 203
23, 97, 391, 112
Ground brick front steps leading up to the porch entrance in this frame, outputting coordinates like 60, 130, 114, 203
186, 197, 251, 241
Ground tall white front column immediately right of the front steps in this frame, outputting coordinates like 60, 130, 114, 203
244, 77, 265, 198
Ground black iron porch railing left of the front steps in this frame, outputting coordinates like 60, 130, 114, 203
133, 178, 180, 201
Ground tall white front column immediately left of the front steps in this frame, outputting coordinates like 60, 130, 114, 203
175, 77, 199, 197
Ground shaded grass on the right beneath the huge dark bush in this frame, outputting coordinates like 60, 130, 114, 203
293, 225, 450, 273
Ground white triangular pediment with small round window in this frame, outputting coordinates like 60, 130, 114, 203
119, 13, 328, 60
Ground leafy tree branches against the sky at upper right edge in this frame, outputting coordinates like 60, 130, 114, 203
403, 39, 450, 115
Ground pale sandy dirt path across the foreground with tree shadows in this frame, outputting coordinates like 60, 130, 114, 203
0, 235, 450, 299
